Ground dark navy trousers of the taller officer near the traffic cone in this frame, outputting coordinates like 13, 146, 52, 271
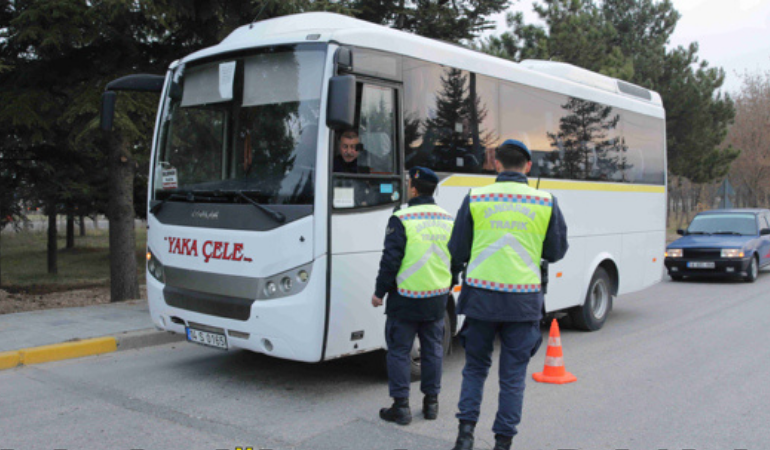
457, 317, 543, 437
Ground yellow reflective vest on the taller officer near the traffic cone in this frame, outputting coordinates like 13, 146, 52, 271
466, 182, 553, 293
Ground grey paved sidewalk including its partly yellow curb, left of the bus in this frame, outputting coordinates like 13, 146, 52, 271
0, 300, 184, 370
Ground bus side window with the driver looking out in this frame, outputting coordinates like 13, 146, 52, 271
332, 83, 402, 209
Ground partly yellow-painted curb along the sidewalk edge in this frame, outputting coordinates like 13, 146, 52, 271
0, 329, 185, 370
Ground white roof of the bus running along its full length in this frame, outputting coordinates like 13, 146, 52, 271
182, 12, 664, 118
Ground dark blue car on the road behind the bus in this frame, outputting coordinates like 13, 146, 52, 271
665, 209, 770, 282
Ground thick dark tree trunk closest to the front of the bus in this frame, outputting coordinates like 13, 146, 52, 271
108, 132, 139, 302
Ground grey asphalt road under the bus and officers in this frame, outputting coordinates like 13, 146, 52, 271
0, 272, 770, 450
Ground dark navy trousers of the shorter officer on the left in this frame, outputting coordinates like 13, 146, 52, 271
385, 316, 444, 398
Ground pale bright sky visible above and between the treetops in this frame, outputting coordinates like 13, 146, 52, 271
486, 0, 770, 95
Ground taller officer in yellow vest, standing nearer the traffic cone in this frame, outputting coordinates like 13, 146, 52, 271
449, 139, 568, 450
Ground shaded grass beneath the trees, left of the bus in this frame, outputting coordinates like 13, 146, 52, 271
0, 227, 147, 294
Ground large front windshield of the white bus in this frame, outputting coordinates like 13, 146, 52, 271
153, 45, 325, 204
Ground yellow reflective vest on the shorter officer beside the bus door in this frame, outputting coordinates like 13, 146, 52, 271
393, 205, 454, 298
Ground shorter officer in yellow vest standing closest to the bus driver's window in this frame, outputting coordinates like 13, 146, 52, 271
372, 167, 453, 425
